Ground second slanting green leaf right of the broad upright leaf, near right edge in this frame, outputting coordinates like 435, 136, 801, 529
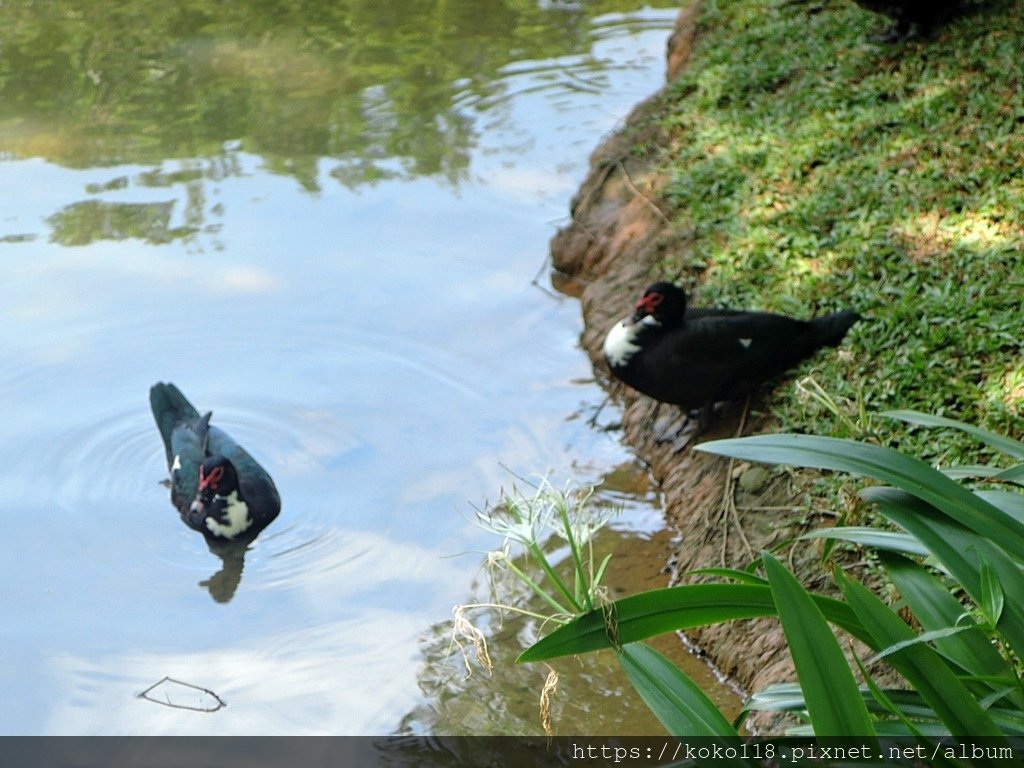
882, 554, 1024, 692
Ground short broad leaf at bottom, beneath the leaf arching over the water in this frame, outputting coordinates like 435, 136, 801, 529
618, 643, 740, 741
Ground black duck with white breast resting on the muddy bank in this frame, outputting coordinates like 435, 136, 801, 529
604, 283, 860, 427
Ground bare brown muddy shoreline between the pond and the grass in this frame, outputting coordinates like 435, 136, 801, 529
551, 0, 813, 708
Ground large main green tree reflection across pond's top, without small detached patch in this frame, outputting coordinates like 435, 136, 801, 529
0, 0, 663, 189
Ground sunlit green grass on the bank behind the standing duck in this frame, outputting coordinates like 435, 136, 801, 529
637, 0, 1024, 464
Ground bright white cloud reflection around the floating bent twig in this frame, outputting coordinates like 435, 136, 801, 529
39, 618, 428, 735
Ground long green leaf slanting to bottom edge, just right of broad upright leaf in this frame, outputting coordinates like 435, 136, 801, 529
839, 575, 1002, 736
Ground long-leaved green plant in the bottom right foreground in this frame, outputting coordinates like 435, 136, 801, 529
519, 411, 1024, 739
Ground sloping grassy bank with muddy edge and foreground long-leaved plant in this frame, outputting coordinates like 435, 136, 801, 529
507, 0, 1024, 735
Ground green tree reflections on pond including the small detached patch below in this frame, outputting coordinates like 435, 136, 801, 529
0, 0, 679, 248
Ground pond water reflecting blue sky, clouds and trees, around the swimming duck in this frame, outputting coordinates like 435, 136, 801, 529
0, 0, 737, 734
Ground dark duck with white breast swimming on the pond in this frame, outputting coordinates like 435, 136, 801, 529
150, 382, 281, 543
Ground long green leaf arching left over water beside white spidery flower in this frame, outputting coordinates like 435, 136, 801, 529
517, 584, 870, 662
